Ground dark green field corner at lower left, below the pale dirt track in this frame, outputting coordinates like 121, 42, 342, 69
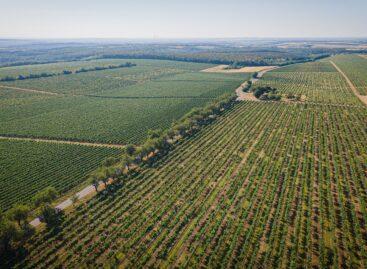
0, 139, 121, 209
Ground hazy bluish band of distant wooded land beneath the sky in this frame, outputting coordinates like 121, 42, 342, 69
0, 40, 366, 67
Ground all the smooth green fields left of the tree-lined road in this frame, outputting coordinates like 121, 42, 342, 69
0, 59, 248, 209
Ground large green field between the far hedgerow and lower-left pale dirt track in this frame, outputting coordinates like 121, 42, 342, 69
0, 60, 249, 144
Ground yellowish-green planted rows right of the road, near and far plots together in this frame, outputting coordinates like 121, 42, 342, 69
7, 57, 367, 268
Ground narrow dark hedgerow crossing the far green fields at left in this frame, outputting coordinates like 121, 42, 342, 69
0, 62, 136, 82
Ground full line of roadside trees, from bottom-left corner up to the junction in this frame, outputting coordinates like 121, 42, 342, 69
0, 94, 237, 260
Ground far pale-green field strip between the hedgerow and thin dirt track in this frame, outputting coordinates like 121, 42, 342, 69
0, 59, 247, 97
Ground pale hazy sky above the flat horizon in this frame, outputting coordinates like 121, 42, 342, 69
0, 0, 367, 38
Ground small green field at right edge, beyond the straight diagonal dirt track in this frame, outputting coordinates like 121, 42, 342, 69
331, 55, 367, 95
